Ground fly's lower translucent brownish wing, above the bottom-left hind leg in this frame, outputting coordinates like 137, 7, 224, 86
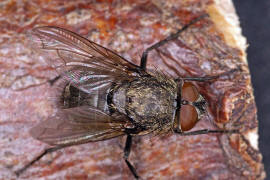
30, 106, 129, 146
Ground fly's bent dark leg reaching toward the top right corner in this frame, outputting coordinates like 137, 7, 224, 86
140, 14, 208, 70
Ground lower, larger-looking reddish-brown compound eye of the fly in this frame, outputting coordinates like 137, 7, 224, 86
178, 105, 198, 131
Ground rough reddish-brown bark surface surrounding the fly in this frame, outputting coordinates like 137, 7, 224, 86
0, 0, 265, 180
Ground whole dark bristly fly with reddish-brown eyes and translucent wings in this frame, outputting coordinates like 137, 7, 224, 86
16, 15, 237, 179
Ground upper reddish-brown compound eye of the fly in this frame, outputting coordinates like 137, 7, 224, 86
182, 82, 199, 102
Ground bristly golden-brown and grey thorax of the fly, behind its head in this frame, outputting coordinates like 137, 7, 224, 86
125, 77, 175, 129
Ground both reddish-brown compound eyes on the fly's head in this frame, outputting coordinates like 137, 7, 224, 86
178, 82, 200, 131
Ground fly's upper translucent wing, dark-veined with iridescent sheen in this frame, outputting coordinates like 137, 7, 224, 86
33, 26, 144, 92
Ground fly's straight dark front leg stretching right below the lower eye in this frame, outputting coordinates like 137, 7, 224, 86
174, 128, 239, 136
